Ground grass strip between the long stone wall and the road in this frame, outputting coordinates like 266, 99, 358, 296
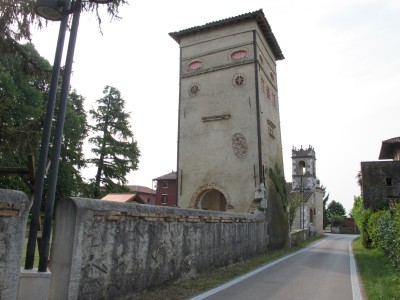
131, 234, 324, 300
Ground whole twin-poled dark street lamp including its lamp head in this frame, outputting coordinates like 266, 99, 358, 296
25, 0, 113, 272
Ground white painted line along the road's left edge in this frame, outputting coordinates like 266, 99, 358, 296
190, 237, 328, 300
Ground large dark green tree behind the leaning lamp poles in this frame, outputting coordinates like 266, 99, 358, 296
0, 44, 88, 207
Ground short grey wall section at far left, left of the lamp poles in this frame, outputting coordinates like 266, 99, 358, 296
0, 189, 29, 299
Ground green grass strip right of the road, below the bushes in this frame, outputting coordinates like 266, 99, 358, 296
353, 239, 400, 300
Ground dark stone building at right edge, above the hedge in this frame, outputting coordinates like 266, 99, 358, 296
361, 137, 400, 209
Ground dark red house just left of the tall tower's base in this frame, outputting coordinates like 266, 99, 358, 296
153, 171, 177, 206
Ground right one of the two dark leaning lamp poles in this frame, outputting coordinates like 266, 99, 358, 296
39, 0, 82, 272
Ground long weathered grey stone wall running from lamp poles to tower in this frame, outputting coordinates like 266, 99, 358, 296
50, 198, 268, 299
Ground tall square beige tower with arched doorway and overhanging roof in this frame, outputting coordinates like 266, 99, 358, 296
170, 10, 284, 244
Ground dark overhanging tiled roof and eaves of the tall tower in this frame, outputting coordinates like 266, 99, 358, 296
169, 9, 285, 60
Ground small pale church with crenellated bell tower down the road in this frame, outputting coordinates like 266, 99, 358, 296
287, 146, 324, 234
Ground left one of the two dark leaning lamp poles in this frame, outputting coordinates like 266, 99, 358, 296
25, 0, 71, 269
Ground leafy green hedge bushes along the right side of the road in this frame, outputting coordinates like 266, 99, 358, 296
352, 197, 400, 271
